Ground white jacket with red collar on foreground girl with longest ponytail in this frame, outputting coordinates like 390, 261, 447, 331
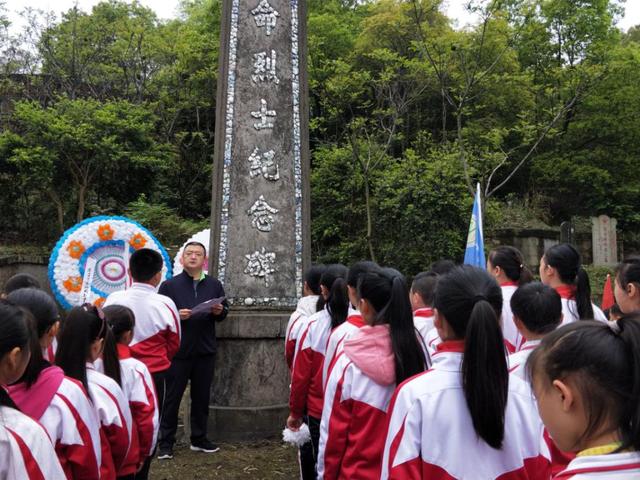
381, 341, 550, 480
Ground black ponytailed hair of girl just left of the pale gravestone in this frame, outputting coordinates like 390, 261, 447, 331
544, 243, 594, 320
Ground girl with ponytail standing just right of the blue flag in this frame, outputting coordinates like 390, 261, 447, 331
487, 246, 533, 353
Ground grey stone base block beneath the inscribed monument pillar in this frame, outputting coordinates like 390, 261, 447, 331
209, 307, 291, 441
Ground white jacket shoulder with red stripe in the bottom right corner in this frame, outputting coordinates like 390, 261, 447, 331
553, 452, 640, 480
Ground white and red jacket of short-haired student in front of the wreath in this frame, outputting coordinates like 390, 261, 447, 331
104, 283, 180, 373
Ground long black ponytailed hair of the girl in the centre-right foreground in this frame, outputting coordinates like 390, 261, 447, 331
434, 265, 509, 449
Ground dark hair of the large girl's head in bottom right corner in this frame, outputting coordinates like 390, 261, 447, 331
527, 314, 640, 451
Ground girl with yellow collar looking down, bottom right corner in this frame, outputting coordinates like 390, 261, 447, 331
527, 314, 640, 480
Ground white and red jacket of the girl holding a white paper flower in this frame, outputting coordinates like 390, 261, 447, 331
289, 308, 331, 418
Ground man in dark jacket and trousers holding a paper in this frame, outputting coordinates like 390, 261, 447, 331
158, 242, 229, 459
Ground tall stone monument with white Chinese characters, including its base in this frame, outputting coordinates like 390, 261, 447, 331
209, 0, 310, 439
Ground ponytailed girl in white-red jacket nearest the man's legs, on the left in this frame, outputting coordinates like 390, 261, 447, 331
102, 305, 160, 479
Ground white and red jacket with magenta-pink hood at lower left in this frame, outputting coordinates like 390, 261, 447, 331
8, 366, 102, 480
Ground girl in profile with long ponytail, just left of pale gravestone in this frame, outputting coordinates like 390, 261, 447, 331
539, 243, 607, 325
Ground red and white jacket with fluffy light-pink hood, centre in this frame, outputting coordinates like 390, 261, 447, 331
318, 325, 396, 480
